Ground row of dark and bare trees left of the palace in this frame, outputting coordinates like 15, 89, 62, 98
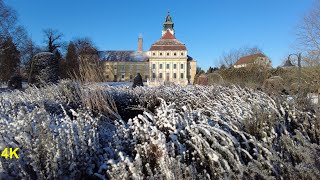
0, 0, 98, 82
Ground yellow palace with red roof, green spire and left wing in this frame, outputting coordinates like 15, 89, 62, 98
98, 13, 196, 85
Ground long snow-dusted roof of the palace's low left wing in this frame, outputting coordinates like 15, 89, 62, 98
98, 51, 149, 62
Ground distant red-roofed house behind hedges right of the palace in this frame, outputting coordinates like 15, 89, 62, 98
233, 53, 271, 68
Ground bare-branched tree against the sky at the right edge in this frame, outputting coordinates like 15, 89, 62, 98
297, 0, 320, 66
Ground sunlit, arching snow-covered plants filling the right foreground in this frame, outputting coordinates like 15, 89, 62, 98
102, 86, 320, 179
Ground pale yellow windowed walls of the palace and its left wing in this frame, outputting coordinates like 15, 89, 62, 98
102, 51, 196, 85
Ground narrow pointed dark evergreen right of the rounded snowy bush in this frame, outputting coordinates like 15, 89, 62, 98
66, 41, 79, 76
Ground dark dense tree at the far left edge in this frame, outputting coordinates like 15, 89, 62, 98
0, 38, 20, 81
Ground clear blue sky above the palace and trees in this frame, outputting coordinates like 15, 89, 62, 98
4, 0, 313, 69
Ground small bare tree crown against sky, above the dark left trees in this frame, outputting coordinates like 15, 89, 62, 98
43, 28, 63, 53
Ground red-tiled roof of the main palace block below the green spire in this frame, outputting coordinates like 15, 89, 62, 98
150, 30, 187, 51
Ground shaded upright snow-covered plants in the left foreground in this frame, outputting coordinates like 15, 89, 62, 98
0, 81, 112, 179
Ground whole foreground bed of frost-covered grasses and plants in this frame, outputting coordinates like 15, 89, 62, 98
0, 82, 320, 179
